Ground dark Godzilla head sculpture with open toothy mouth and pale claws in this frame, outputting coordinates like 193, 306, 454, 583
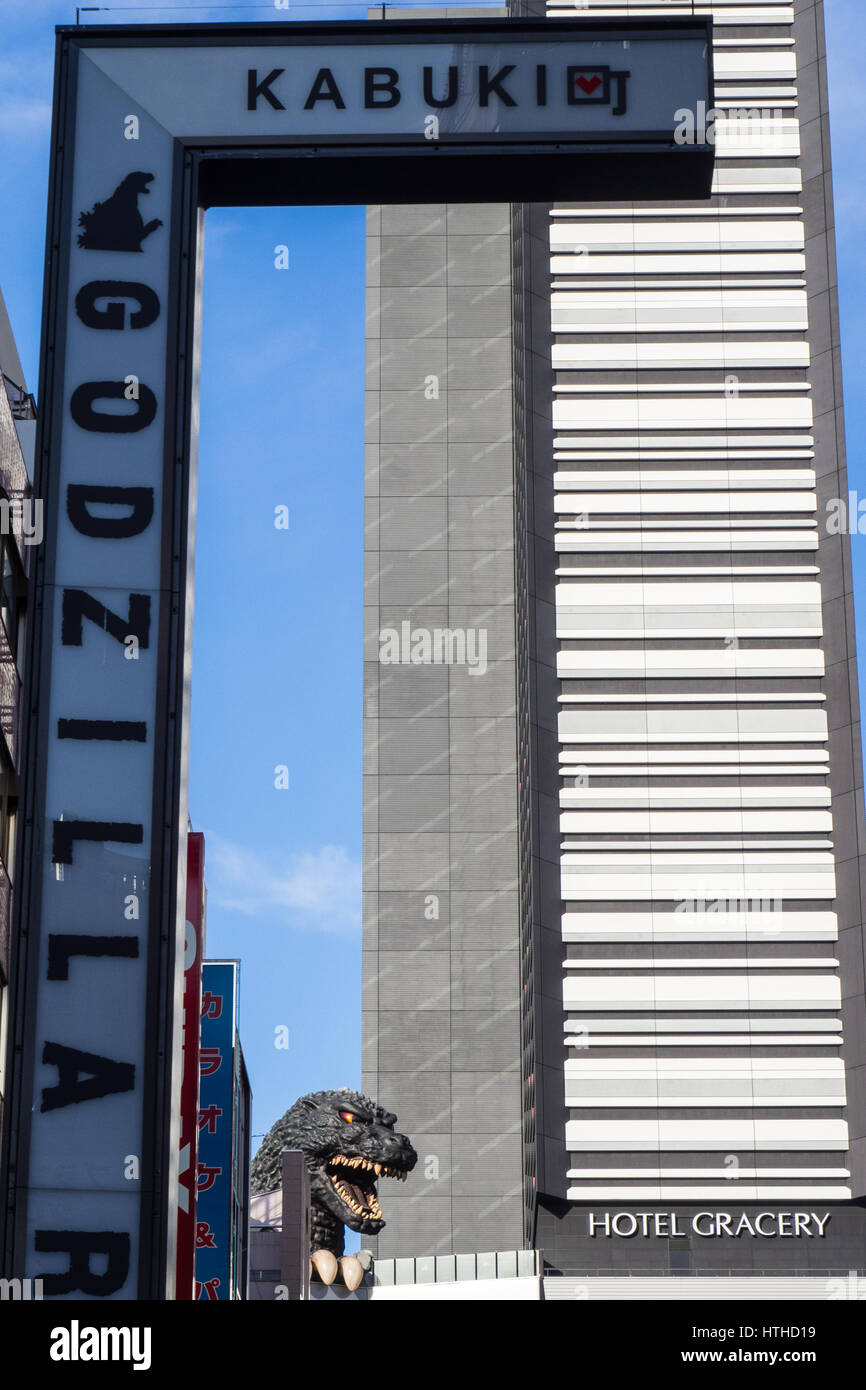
250, 1088, 418, 1287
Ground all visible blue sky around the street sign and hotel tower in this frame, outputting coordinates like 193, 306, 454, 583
0, 0, 866, 1150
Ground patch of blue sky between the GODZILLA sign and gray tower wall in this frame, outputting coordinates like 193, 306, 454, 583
190, 207, 364, 1131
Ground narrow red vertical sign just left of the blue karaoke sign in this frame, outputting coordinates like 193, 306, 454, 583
175, 831, 204, 1300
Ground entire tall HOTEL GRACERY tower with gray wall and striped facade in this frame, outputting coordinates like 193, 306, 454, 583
364, 0, 866, 1295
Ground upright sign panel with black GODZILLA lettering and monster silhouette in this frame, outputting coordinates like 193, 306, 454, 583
19, 48, 179, 1298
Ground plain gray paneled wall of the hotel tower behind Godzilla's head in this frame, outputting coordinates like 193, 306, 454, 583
363, 204, 523, 1257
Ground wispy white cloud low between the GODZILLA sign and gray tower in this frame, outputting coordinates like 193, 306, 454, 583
204, 831, 361, 935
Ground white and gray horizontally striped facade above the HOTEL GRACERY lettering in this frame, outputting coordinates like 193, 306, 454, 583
548, 0, 851, 1204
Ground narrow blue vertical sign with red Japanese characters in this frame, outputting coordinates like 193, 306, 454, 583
196, 960, 238, 1301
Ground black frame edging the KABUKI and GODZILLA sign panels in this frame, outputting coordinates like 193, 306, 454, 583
0, 10, 714, 1300
